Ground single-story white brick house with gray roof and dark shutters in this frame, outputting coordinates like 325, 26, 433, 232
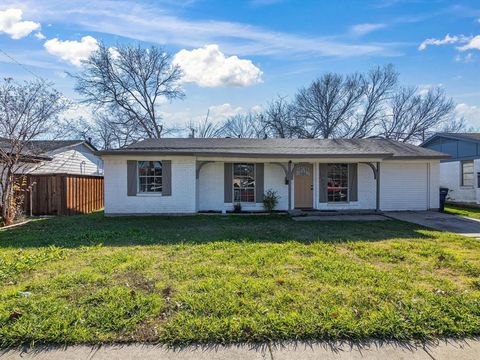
98, 138, 447, 215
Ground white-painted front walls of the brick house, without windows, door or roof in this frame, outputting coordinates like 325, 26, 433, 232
104, 156, 439, 215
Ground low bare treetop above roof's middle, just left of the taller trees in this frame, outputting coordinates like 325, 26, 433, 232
220, 113, 266, 138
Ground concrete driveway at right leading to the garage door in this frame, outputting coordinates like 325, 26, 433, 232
385, 211, 480, 238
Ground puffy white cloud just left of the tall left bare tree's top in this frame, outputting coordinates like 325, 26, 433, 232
43, 36, 98, 66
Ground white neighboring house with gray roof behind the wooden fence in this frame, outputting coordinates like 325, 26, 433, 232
22, 140, 103, 175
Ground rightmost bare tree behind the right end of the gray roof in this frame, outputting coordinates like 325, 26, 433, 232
381, 87, 455, 142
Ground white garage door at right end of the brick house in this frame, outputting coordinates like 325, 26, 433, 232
380, 162, 428, 210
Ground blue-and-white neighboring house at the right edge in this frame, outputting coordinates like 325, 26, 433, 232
421, 133, 480, 204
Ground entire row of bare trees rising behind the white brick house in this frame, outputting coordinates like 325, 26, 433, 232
63, 44, 465, 148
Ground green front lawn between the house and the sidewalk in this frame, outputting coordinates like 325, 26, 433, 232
0, 213, 480, 346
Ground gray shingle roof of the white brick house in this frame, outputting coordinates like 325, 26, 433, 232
98, 138, 449, 159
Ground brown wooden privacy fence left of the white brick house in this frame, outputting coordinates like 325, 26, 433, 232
20, 174, 104, 215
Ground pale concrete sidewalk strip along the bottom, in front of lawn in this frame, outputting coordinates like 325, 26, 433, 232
0, 340, 480, 360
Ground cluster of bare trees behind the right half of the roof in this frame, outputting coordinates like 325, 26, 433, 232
196, 65, 465, 143
